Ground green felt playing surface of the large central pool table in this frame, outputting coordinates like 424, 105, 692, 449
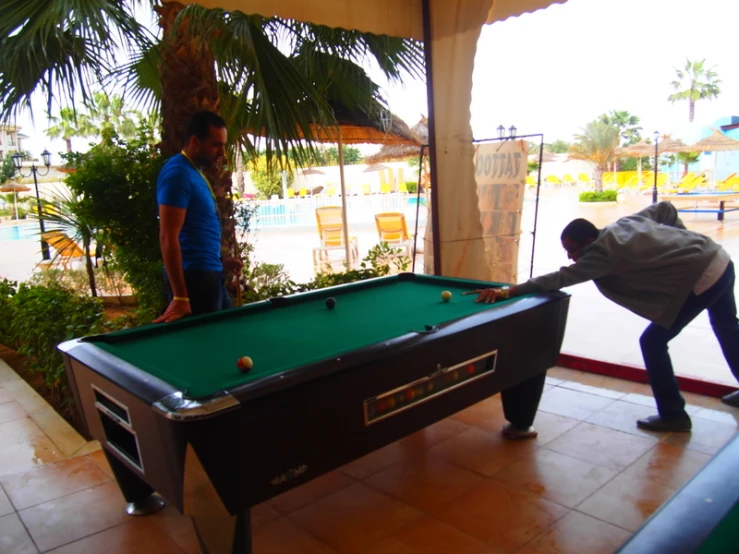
95, 277, 513, 398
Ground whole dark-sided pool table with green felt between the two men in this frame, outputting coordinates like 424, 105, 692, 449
59, 273, 569, 553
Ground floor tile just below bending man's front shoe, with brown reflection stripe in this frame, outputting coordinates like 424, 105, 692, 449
624, 442, 711, 490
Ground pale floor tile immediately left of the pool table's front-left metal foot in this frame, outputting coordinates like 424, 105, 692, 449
18, 482, 130, 552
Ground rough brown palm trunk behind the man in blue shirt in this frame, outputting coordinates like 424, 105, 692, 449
155, 2, 236, 260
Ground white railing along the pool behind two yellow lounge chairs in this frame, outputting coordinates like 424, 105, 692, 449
254, 193, 426, 229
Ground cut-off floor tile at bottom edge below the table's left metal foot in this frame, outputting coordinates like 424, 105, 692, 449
44, 517, 182, 554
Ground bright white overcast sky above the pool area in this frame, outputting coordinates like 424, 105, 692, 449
10, 0, 739, 160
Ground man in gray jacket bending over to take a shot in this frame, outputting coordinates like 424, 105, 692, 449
477, 202, 739, 432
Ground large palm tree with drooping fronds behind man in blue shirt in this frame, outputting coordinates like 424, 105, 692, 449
0, 0, 423, 254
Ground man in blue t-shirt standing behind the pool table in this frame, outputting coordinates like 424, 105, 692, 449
154, 111, 243, 323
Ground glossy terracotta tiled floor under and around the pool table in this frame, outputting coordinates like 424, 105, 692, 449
0, 362, 739, 554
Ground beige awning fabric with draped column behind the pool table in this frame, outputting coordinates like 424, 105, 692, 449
178, 0, 566, 278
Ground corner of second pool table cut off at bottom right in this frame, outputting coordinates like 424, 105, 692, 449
618, 434, 739, 554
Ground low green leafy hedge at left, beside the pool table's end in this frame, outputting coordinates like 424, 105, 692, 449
10, 283, 103, 397
